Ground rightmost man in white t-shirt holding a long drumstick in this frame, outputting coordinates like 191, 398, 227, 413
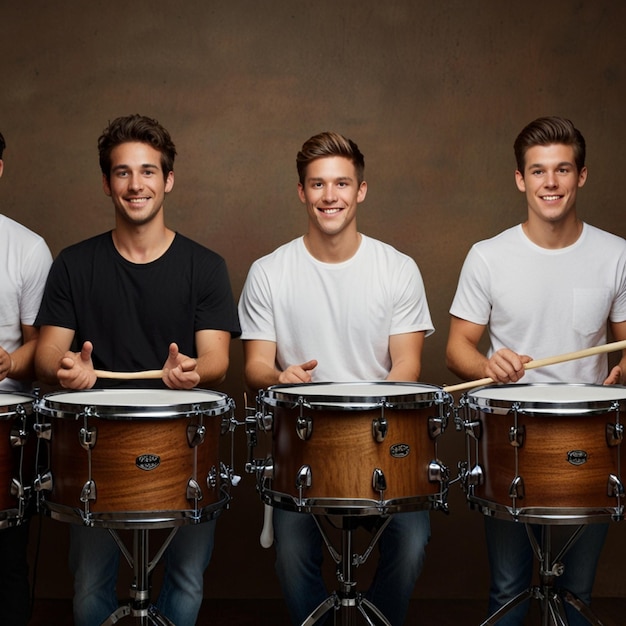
446, 117, 626, 626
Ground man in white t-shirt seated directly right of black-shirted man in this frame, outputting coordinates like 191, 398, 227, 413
239, 132, 434, 626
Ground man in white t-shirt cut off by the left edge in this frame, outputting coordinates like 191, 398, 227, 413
0, 129, 52, 626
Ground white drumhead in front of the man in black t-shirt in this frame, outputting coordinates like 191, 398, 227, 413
44, 389, 224, 407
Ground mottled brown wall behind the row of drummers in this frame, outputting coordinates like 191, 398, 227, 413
0, 0, 626, 597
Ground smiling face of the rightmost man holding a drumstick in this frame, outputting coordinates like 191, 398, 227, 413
515, 144, 587, 224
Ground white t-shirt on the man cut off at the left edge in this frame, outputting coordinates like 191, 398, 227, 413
0, 215, 52, 391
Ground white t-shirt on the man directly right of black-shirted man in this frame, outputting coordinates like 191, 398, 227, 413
239, 236, 434, 382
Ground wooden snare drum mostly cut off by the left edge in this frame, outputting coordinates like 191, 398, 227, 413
0, 391, 35, 529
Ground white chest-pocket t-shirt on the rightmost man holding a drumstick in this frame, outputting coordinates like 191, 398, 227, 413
450, 224, 626, 384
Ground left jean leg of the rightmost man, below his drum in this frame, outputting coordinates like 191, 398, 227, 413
484, 516, 534, 626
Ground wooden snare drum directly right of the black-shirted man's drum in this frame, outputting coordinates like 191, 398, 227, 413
249, 382, 450, 515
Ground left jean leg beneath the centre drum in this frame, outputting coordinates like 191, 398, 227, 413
274, 508, 328, 624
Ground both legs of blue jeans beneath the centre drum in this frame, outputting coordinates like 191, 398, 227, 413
274, 508, 430, 626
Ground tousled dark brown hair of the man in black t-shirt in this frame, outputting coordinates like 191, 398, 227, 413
98, 115, 176, 180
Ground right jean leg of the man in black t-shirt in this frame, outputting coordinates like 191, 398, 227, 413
156, 519, 217, 626
